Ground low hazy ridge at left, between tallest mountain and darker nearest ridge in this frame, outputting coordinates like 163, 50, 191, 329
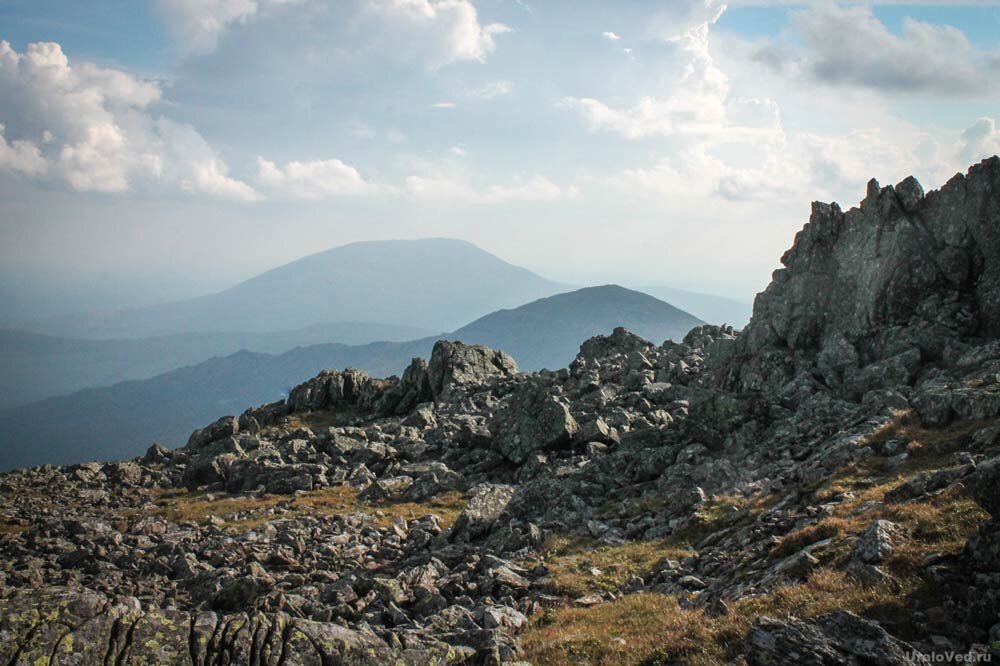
0, 322, 434, 409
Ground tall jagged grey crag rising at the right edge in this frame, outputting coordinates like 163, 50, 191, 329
731, 158, 1000, 397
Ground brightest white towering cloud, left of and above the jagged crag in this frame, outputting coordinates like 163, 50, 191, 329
564, 2, 988, 215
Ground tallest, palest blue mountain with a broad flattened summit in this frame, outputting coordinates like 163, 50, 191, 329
19, 238, 566, 339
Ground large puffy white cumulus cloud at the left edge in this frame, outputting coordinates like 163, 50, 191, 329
0, 41, 258, 200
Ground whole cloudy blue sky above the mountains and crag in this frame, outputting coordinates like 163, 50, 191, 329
0, 0, 1000, 309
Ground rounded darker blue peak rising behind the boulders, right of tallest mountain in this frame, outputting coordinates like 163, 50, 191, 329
452, 285, 705, 370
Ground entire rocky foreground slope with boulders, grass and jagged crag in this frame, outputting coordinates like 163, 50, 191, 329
0, 158, 1000, 666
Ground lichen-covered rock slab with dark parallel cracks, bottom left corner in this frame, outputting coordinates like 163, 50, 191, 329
0, 588, 450, 666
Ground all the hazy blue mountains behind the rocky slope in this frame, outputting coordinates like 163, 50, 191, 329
0, 239, 750, 468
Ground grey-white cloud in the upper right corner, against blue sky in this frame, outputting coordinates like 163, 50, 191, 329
754, 6, 1000, 95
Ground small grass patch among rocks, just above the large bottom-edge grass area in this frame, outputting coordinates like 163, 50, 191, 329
542, 536, 693, 597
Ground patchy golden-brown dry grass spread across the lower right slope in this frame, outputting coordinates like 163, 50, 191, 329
522, 413, 992, 666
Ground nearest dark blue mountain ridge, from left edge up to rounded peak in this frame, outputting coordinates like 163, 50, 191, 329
0, 286, 702, 469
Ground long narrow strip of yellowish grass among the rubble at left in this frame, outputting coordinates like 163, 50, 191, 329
147, 485, 465, 532
